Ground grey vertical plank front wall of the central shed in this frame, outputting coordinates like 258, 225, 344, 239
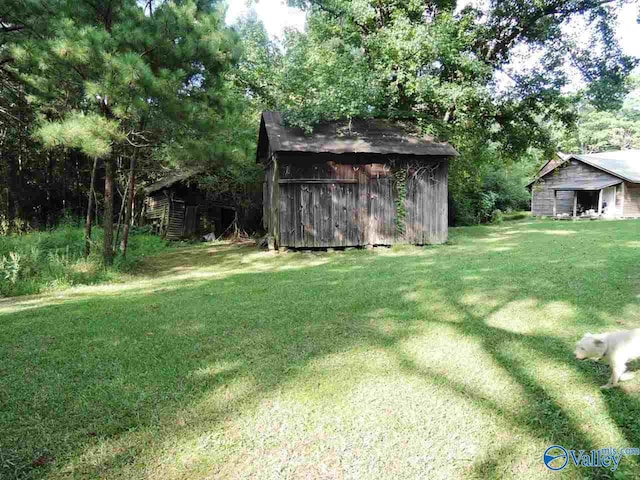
276, 158, 448, 248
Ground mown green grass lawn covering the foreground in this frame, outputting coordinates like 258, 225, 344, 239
0, 220, 640, 480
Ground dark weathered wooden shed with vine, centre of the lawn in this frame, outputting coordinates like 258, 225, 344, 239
257, 112, 456, 248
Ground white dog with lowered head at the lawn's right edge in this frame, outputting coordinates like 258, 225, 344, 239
575, 328, 640, 388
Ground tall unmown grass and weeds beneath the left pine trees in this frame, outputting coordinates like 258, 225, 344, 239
0, 224, 175, 298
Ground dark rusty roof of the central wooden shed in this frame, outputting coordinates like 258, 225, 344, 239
258, 112, 457, 157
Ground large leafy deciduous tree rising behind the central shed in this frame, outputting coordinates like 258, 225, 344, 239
270, 0, 637, 224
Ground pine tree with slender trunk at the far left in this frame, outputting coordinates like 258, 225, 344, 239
0, 0, 238, 265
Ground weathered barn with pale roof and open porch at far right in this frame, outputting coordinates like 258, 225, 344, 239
528, 150, 640, 218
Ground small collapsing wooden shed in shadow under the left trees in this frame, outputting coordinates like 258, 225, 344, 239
142, 170, 235, 240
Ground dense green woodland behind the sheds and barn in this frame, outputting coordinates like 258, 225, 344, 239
0, 0, 640, 264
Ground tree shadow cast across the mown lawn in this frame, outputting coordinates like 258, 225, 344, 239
0, 223, 640, 478
